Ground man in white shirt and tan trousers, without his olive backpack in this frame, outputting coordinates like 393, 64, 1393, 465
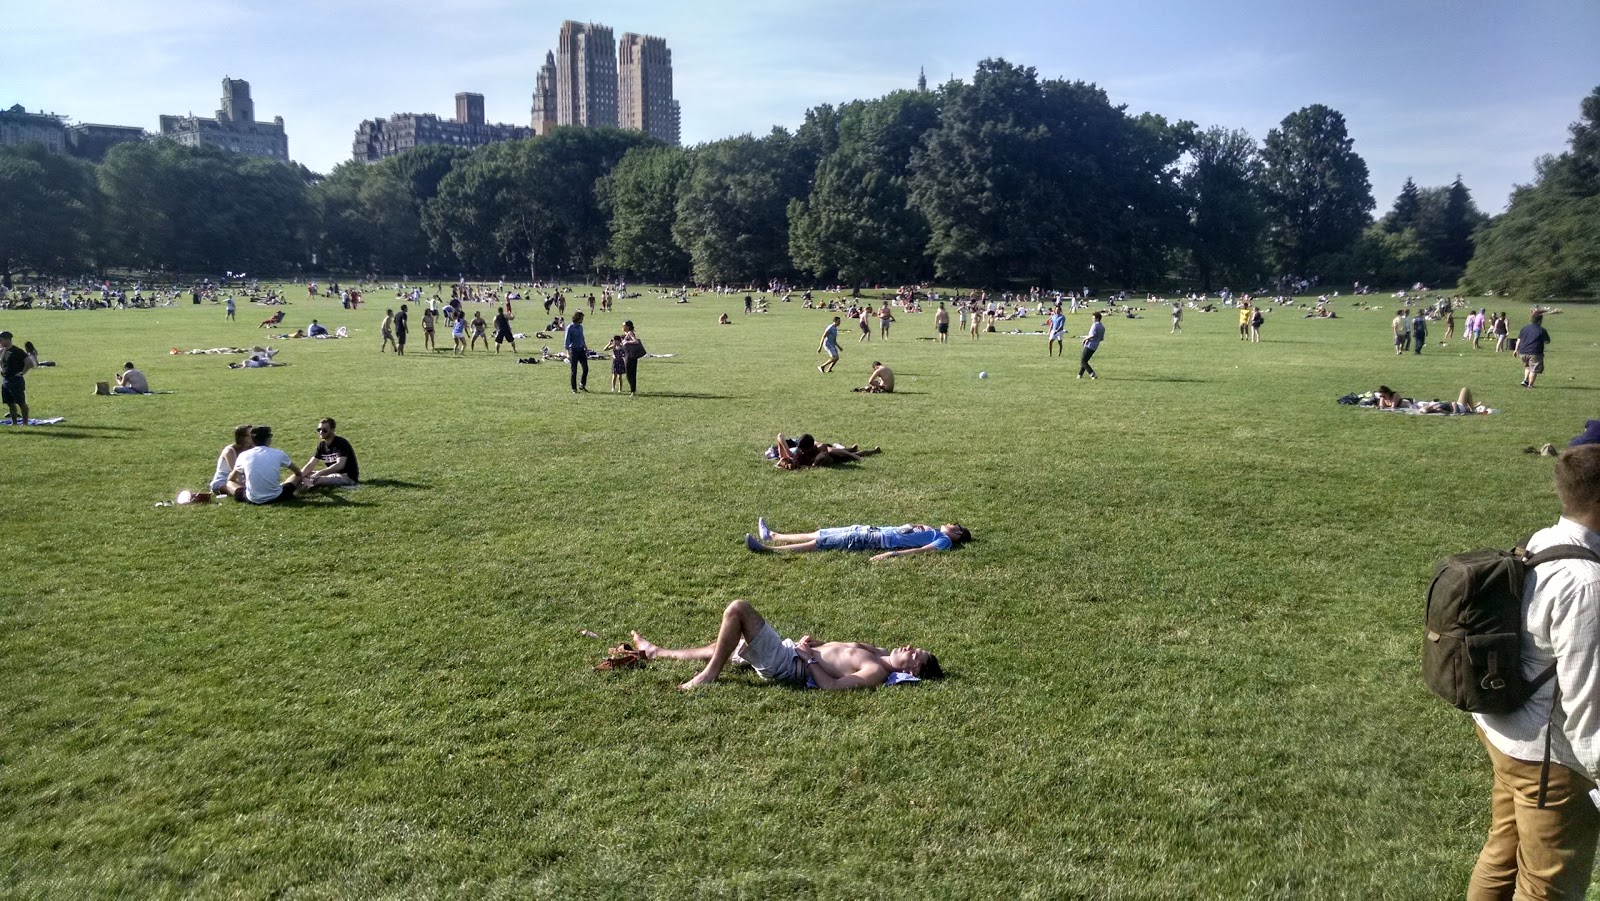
1467, 445, 1600, 899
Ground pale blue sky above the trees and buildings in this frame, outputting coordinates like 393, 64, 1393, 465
0, 0, 1600, 213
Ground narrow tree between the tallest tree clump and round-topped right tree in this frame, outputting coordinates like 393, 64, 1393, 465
1182, 126, 1267, 291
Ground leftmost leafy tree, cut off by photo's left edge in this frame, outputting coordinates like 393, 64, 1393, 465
0, 144, 101, 286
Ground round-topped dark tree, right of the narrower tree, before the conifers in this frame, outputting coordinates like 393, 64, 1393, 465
1261, 104, 1374, 275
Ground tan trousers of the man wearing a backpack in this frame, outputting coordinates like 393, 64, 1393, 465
1467, 730, 1600, 901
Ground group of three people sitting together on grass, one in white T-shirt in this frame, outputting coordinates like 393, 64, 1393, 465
211, 419, 362, 506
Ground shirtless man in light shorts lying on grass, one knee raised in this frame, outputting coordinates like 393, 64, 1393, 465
634, 600, 944, 691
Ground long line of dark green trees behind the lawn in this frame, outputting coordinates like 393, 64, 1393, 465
0, 59, 1600, 296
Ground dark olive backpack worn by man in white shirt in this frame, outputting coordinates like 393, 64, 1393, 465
1422, 541, 1600, 714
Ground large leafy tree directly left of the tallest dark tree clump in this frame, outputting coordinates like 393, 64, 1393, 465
789, 91, 939, 285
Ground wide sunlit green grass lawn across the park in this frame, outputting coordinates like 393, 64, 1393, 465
0, 288, 1600, 898
